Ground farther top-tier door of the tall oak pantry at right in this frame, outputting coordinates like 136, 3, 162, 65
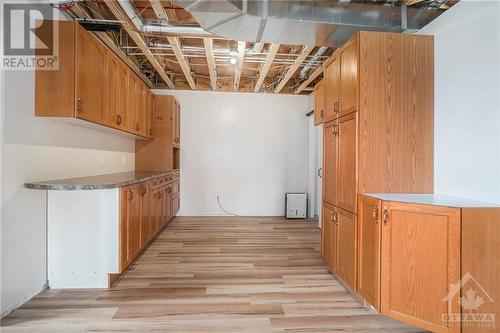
323, 54, 341, 122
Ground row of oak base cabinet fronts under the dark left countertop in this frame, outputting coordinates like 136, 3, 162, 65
119, 175, 179, 272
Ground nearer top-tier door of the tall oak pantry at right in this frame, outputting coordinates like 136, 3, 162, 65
339, 35, 359, 116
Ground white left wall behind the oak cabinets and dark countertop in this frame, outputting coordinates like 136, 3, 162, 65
0, 14, 134, 314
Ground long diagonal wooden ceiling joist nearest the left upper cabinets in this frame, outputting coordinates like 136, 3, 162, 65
104, 1, 175, 89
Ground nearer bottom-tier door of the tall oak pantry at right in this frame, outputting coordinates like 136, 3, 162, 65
336, 209, 356, 291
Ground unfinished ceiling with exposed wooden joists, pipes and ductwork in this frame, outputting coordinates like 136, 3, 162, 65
53, 0, 456, 94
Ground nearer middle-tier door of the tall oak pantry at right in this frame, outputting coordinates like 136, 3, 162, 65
335, 112, 358, 213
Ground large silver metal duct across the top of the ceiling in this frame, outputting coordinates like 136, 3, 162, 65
173, 0, 443, 47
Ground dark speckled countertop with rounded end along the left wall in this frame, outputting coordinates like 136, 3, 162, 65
24, 170, 179, 191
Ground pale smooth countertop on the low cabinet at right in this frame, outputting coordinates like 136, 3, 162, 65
365, 193, 500, 208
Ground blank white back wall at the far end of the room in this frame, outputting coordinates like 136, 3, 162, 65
155, 91, 308, 216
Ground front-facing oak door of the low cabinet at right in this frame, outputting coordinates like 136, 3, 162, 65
381, 202, 460, 332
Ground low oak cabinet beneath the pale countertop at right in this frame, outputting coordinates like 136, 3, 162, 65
358, 195, 500, 333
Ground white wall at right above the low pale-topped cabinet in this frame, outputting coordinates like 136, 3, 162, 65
419, 0, 500, 203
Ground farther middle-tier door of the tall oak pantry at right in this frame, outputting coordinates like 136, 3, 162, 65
323, 123, 338, 205
